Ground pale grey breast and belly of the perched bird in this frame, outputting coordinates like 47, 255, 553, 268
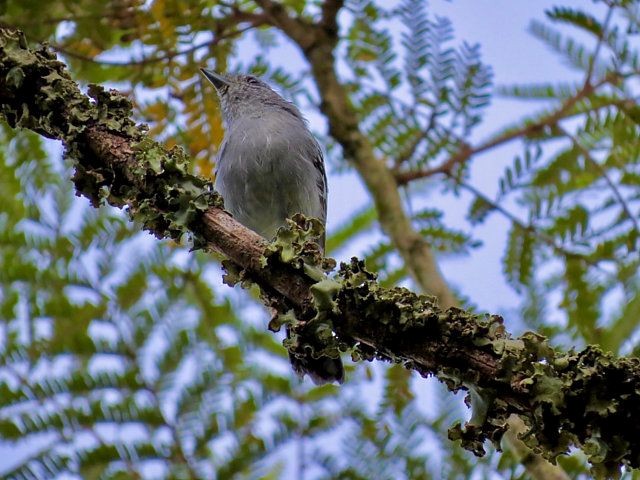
215, 117, 324, 238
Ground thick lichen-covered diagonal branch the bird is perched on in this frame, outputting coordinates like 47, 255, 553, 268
0, 29, 640, 478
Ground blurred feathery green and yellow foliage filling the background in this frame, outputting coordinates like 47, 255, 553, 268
0, 0, 640, 479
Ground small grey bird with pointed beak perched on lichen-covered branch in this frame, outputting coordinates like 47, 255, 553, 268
201, 68, 344, 384
